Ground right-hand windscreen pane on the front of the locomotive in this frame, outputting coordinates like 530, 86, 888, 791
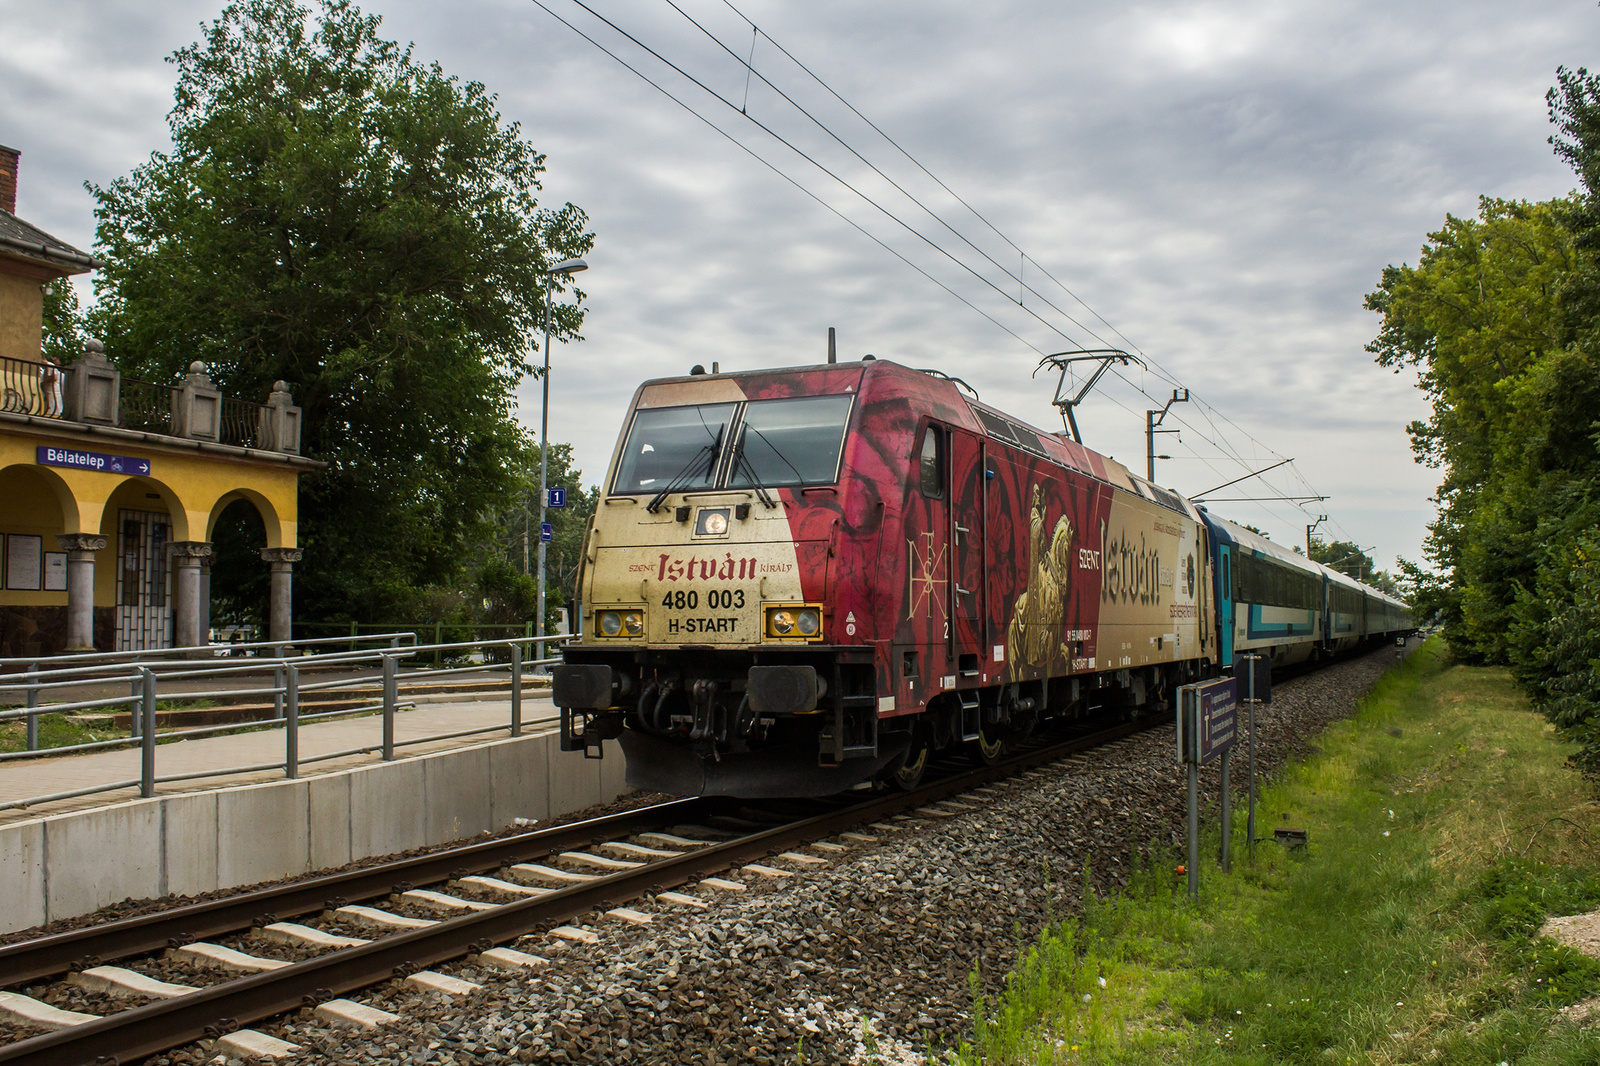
728, 395, 851, 488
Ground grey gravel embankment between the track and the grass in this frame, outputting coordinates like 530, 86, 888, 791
137, 643, 1414, 1066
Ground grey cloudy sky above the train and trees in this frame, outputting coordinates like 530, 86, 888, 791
0, 0, 1600, 567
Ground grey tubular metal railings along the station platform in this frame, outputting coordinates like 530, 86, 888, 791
0, 634, 573, 810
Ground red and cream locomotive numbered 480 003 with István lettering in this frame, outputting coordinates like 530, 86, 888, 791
554, 357, 1219, 797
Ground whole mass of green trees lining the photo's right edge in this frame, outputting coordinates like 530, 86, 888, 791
1366, 67, 1600, 770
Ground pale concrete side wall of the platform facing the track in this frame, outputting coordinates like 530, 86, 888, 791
0, 733, 627, 933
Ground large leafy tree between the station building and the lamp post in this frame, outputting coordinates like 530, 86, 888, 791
90, 0, 592, 621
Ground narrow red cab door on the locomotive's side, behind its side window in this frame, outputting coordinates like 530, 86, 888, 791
949, 429, 989, 669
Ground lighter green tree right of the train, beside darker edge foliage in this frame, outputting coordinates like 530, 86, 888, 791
1366, 191, 1600, 663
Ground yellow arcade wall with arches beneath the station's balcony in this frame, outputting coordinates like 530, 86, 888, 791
0, 423, 304, 607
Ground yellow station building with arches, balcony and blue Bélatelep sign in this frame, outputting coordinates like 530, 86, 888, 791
0, 146, 322, 658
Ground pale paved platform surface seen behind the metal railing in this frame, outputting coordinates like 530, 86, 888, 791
0, 696, 558, 824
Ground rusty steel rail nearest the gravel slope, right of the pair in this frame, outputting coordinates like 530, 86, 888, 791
0, 717, 1165, 1066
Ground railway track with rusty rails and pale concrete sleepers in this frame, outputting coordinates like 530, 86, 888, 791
0, 715, 1165, 1066
